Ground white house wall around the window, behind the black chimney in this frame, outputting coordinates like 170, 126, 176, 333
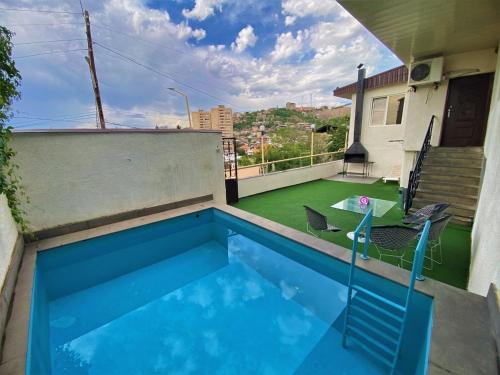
349, 84, 408, 177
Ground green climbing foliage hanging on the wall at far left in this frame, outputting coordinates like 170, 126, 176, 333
0, 26, 29, 232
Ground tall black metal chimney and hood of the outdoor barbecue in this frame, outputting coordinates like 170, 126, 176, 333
344, 64, 368, 163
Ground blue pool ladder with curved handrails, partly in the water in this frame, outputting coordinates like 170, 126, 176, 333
342, 209, 431, 375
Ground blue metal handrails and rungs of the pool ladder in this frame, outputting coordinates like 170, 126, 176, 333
342, 209, 431, 375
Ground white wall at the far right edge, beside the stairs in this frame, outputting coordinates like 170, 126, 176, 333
468, 46, 500, 295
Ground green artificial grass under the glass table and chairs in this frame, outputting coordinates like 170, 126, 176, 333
234, 180, 471, 289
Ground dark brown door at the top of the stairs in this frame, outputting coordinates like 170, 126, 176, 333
441, 74, 493, 147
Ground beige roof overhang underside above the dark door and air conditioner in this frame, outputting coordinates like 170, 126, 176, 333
338, 0, 500, 64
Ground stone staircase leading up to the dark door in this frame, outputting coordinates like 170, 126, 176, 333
412, 147, 483, 225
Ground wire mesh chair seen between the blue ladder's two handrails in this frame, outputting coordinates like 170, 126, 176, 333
370, 225, 420, 267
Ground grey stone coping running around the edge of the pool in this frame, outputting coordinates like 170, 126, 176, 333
0, 203, 496, 374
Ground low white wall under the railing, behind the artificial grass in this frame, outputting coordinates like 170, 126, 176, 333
238, 160, 342, 198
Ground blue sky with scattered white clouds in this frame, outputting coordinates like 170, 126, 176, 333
0, 0, 401, 129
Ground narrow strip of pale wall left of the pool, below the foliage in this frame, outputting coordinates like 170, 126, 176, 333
0, 194, 23, 350
